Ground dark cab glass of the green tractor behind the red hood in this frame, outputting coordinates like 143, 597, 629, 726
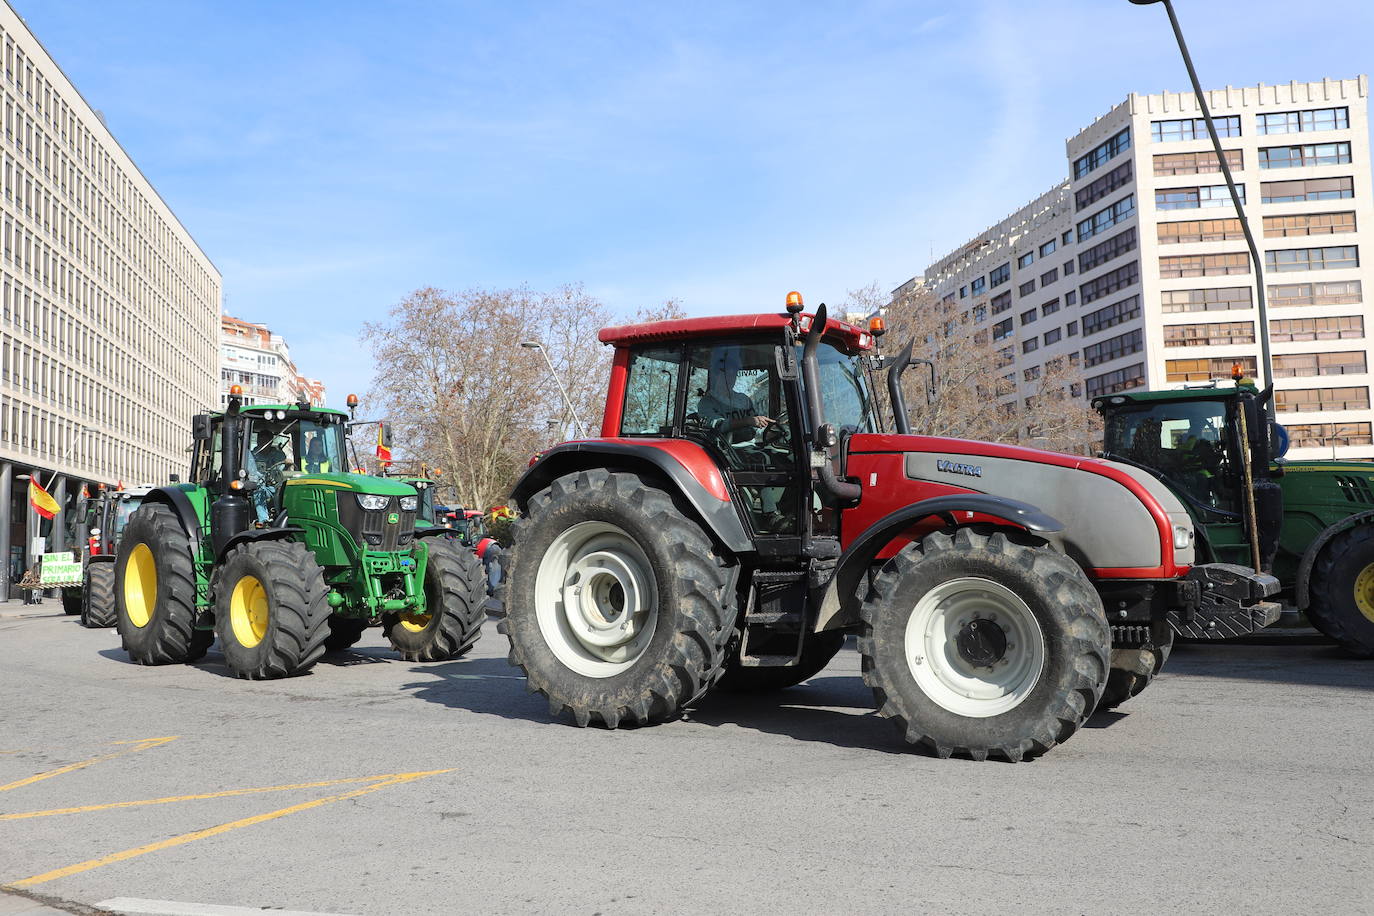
1103, 400, 1238, 512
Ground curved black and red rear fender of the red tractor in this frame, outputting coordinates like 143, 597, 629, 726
511, 439, 754, 553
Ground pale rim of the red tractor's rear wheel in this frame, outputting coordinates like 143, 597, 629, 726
534, 522, 658, 677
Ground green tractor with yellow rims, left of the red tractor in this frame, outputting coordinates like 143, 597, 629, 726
115, 386, 485, 678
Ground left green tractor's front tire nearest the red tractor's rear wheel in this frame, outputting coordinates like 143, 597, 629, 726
385, 537, 486, 662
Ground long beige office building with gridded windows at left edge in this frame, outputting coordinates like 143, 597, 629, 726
0, 4, 221, 600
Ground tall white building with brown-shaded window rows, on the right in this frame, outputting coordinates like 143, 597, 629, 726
923, 76, 1374, 457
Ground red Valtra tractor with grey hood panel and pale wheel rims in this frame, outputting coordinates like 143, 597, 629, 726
502, 294, 1279, 761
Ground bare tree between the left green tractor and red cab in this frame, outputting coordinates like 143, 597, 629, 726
359, 286, 682, 508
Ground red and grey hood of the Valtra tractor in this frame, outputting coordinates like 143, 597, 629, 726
846, 434, 1194, 578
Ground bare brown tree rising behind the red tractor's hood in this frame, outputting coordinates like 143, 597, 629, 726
844, 283, 1096, 453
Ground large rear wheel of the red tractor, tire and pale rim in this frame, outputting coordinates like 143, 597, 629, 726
500, 470, 736, 728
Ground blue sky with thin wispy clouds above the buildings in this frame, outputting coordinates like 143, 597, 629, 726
10, 0, 1374, 402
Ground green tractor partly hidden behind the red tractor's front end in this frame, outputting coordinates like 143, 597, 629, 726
1092, 378, 1374, 658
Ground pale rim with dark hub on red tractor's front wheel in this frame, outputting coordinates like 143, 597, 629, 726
905, 577, 1044, 718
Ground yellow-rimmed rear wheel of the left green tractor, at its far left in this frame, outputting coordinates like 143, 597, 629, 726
114, 503, 201, 665
